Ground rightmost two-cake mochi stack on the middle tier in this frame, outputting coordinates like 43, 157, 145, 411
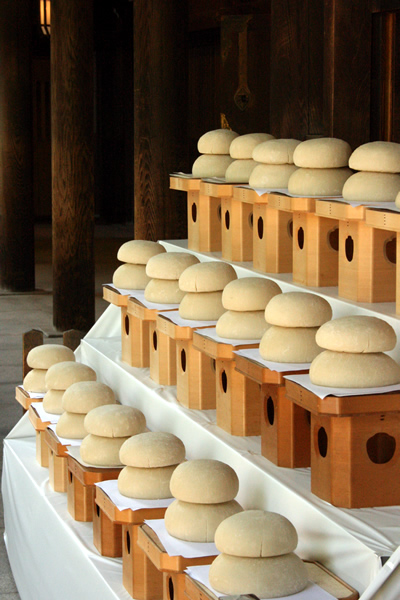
310, 315, 400, 388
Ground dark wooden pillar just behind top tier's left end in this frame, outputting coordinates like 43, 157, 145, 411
133, 0, 188, 240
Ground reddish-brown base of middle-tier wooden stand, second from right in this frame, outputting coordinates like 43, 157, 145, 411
261, 384, 311, 469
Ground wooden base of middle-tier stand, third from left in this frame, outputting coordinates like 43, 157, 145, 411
176, 340, 216, 410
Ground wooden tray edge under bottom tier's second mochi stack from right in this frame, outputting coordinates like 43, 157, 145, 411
137, 525, 219, 573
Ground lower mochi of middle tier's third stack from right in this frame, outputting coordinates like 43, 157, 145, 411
216, 310, 269, 340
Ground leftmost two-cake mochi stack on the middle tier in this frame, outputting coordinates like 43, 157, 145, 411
113, 240, 165, 290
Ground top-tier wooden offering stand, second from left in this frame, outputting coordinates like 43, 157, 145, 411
200, 181, 253, 262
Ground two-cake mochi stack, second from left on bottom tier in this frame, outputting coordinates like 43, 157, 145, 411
43, 361, 96, 415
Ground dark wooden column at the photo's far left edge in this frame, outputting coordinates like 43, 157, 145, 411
0, 0, 35, 291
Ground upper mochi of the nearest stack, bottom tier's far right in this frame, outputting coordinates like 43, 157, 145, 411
215, 510, 298, 558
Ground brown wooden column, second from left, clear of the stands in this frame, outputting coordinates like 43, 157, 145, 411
51, 0, 94, 330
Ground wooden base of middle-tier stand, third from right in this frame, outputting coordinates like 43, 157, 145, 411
216, 359, 261, 435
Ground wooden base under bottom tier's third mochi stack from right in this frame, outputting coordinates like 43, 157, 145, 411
122, 525, 163, 600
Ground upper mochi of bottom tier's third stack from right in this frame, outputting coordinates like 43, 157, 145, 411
119, 431, 185, 469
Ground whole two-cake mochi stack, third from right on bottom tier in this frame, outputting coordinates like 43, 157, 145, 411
118, 431, 185, 500
